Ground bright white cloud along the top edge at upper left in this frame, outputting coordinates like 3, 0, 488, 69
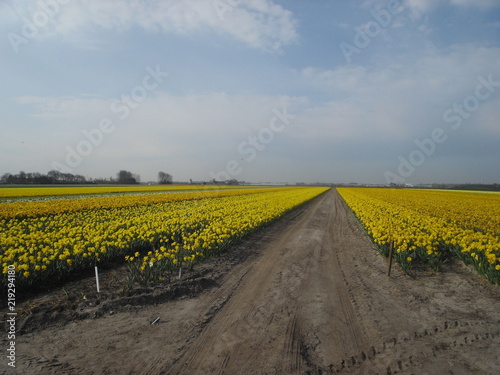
2, 0, 298, 51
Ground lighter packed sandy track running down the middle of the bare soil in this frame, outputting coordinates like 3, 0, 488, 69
166, 189, 365, 374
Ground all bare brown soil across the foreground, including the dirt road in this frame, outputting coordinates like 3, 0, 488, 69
0, 190, 500, 375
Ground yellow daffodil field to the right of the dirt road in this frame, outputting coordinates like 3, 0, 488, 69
337, 188, 500, 284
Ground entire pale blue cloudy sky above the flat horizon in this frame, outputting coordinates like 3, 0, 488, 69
0, 0, 500, 184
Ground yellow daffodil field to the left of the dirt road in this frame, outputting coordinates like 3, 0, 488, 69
0, 187, 327, 288
